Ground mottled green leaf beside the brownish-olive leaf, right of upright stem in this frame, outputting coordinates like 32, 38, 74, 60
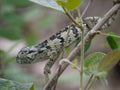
84, 52, 105, 74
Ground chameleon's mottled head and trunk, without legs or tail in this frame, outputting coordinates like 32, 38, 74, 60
16, 24, 88, 64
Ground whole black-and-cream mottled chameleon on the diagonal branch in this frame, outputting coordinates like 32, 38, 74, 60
16, 15, 115, 74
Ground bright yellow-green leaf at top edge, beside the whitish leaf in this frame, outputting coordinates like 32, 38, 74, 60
57, 0, 81, 11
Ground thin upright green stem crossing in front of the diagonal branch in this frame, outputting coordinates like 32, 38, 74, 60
80, 30, 84, 90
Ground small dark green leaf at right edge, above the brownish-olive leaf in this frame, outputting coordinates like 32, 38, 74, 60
106, 33, 120, 49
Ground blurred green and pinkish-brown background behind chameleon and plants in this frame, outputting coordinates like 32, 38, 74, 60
0, 0, 120, 90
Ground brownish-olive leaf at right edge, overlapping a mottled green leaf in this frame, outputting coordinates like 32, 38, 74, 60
98, 50, 120, 71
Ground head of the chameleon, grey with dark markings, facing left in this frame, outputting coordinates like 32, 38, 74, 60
16, 47, 37, 64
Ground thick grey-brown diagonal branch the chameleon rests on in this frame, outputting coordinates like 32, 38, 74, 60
43, 4, 120, 90
